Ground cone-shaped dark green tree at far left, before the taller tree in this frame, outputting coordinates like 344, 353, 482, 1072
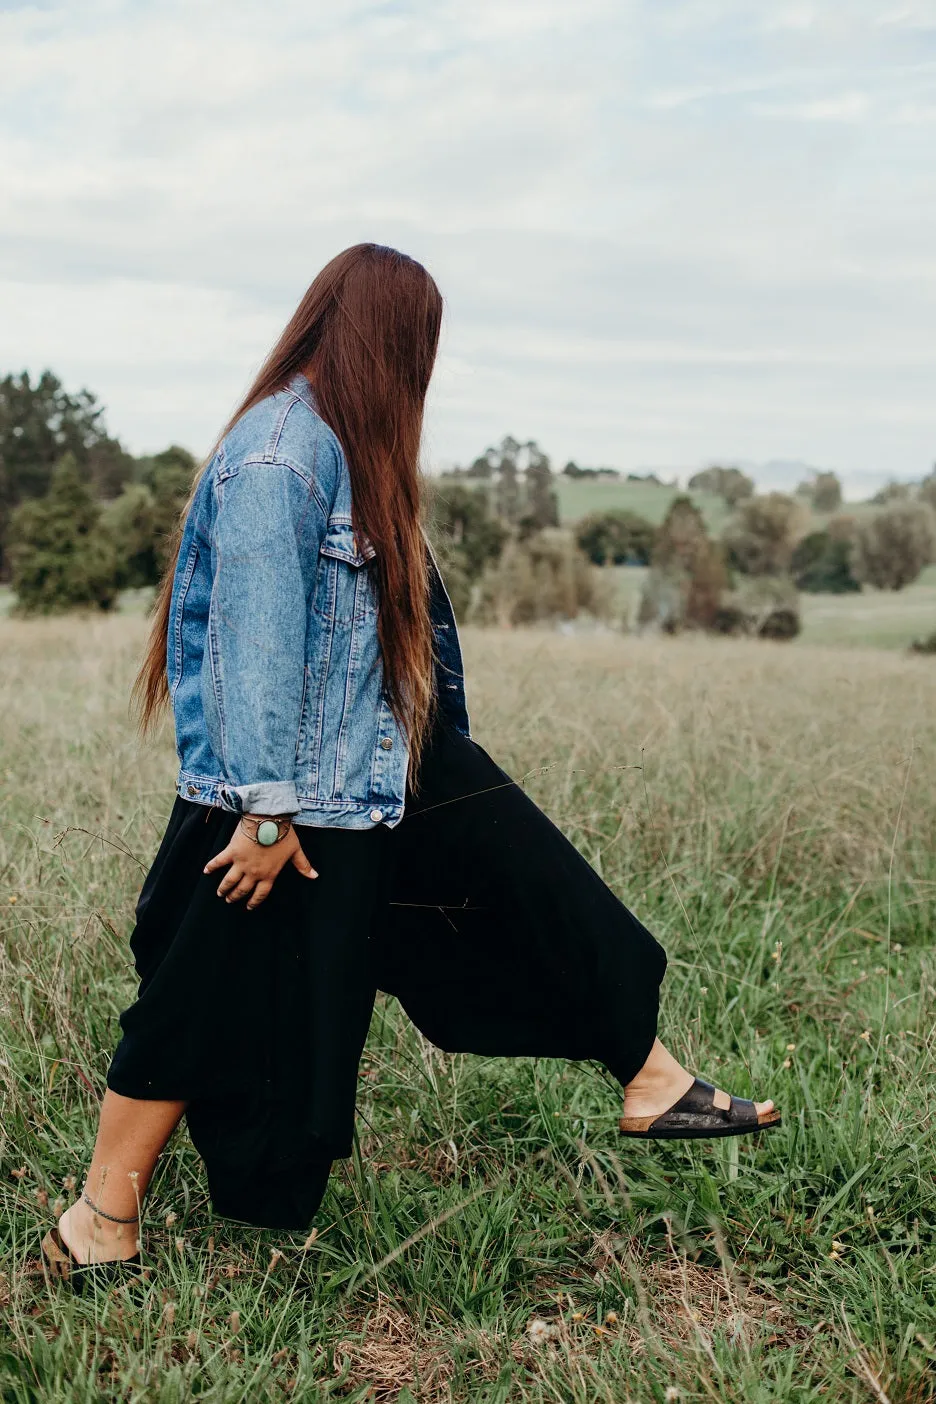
10, 453, 118, 614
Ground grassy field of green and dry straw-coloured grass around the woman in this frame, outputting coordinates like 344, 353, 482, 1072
0, 615, 936, 1404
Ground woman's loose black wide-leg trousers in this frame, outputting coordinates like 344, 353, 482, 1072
107, 722, 667, 1230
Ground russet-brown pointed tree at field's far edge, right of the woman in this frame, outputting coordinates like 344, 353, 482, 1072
639, 496, 727, 633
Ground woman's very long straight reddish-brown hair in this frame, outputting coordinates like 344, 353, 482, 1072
133, 244, 442, 767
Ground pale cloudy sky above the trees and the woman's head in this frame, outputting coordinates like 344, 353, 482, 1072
0, 0, 936, 497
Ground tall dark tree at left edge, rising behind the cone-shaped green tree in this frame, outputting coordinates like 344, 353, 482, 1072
0, 371, 132, 570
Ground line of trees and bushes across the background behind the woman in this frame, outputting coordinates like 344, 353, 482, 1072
0, 371, 936, 637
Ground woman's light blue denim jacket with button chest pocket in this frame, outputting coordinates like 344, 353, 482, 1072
168, 375, 469, 828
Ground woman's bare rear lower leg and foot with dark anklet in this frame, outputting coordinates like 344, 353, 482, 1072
59, 1088, 185, 1262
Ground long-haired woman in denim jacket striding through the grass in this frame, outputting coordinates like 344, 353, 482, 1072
44, 244, 779, 1280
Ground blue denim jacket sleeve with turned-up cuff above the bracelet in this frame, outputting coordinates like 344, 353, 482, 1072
202, 462, 324, 814
